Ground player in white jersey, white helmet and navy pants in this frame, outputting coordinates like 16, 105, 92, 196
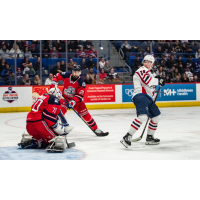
121, 55, 165, 148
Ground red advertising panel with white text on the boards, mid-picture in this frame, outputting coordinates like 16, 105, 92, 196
84, 85, 115, 103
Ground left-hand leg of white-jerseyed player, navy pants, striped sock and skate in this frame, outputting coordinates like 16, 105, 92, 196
120, 94, 150, 148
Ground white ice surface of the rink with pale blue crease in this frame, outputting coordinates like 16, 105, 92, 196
0, 107, 200, 160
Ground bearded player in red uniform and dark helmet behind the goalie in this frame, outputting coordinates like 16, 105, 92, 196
50, 65, 109, 136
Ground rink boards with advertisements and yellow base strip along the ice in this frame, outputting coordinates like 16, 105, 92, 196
0, 83, 200, 113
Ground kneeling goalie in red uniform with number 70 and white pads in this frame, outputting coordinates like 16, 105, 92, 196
18, 89, 72, 152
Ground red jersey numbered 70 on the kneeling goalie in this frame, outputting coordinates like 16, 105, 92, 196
26, 94, 61, 127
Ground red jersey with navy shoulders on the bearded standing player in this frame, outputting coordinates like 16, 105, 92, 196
50, 72, 86, 102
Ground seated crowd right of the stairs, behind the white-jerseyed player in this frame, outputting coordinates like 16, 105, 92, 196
121, 40, 200, 83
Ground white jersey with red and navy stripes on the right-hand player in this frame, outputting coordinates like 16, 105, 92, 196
132, 66, 158, 99
